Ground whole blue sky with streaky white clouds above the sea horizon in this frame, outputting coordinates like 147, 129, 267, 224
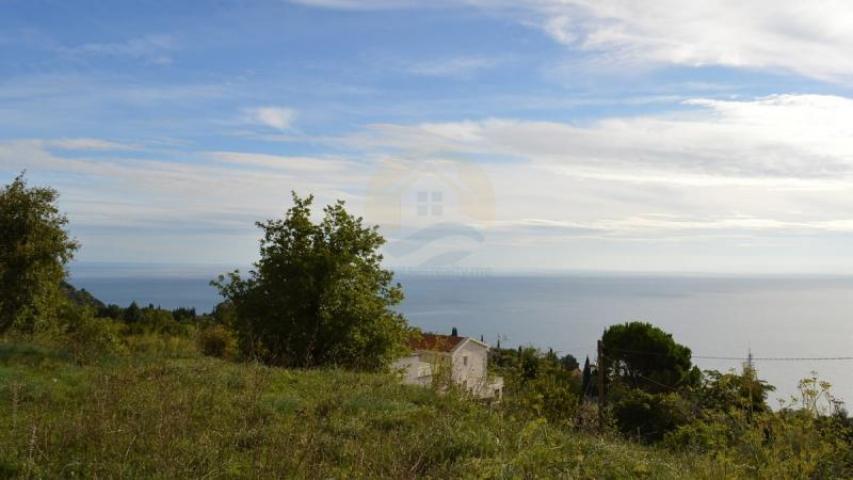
5, 0, 853, 274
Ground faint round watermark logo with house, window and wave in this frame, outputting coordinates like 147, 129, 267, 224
366, 158, 495, 275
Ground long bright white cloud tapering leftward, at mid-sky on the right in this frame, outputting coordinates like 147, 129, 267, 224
349, 95, 853, 183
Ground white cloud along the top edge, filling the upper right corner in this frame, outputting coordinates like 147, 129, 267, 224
297, 0, 853, 81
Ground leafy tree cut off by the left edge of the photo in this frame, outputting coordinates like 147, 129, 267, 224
0, 173, 78, 333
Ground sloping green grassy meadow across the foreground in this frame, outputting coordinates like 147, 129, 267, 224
0, 343, 824, 479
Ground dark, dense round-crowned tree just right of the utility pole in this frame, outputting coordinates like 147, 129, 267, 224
601, 322, 701, 393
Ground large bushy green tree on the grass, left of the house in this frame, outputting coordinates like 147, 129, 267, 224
213, 193, 408, 370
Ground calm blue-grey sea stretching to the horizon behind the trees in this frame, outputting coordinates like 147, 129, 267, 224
71, 264, 853, 407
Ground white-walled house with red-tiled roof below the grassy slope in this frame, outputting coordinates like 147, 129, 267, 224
392, 334, 503, 399
